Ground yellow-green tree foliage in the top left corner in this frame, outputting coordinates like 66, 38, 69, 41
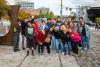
0, 0, 9, 19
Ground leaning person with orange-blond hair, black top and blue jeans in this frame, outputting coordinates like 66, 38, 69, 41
60, 25, 71, 55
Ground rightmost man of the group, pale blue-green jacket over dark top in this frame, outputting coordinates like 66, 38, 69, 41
77, 17, 90, 50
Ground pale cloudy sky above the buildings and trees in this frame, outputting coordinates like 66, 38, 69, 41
7, 0, 100, 15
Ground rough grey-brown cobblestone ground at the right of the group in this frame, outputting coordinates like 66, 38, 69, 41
77, 27, 100, 67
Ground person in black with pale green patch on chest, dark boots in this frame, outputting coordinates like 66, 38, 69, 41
25, 21, 34, 56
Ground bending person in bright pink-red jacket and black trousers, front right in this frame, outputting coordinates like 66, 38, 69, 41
69, 27, 81, 54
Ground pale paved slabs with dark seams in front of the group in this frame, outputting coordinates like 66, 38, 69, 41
0, 46, 79, 67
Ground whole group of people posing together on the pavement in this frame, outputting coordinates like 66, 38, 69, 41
13, 16, 90, 56
